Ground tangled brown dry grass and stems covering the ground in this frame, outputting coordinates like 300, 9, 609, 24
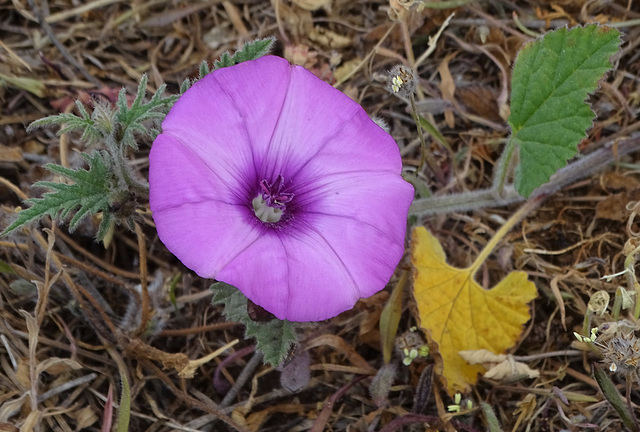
0, 0, 640, 431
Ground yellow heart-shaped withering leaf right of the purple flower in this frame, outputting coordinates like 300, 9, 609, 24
411, 227, 537, 395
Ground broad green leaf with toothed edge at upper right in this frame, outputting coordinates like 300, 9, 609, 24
505, 25, 620, 197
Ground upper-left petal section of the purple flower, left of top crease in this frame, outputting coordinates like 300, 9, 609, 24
162, 57, 291, 193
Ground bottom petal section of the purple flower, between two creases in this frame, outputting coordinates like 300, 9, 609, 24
219, 230, 362, 321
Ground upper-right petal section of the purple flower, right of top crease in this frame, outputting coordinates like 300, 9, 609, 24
261, 61, 402, 181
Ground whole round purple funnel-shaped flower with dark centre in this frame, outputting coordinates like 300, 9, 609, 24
149, 56, 413, 321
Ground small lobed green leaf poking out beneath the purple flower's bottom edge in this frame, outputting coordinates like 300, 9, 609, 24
210, 282, 298, 366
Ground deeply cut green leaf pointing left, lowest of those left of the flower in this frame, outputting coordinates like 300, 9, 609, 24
0, 151, 112, 240
